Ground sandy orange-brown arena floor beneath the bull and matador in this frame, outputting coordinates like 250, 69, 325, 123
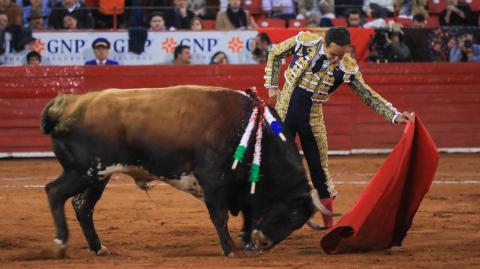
0, 154, 480, 269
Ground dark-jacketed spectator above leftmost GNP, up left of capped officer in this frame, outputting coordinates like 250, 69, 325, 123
48, 0, 94, 29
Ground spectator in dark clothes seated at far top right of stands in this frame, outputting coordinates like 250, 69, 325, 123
439, 0, 473, 26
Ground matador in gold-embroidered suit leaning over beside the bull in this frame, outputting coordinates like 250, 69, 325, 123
264, 27, 413, 228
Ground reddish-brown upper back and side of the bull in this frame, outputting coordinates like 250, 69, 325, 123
67, 86, 253, 147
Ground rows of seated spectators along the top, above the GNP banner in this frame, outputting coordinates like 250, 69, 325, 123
0, 0, 480, 30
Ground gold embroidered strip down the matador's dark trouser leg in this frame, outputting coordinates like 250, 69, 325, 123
310, 103, 337, 197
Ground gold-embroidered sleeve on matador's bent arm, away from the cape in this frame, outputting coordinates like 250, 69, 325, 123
264, 37, 297, 89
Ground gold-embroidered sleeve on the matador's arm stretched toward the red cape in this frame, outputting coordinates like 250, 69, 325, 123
349, 72, 400, 123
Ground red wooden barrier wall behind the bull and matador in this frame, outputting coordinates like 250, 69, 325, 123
0, 63, 480, 152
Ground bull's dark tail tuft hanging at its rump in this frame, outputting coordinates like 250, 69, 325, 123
40, 95, 70, 134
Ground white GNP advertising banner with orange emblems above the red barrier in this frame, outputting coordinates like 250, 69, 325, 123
0, 31, 257, 66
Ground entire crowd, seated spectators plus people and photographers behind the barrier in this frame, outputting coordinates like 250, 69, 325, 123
0, 0, 480, 63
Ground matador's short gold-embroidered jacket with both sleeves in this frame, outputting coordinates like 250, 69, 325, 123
264, 32, 400, 122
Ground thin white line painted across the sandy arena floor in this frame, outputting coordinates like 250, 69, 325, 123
0, 179, 480, 189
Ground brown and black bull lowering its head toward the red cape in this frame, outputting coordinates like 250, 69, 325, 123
41, 86, 330, 256
